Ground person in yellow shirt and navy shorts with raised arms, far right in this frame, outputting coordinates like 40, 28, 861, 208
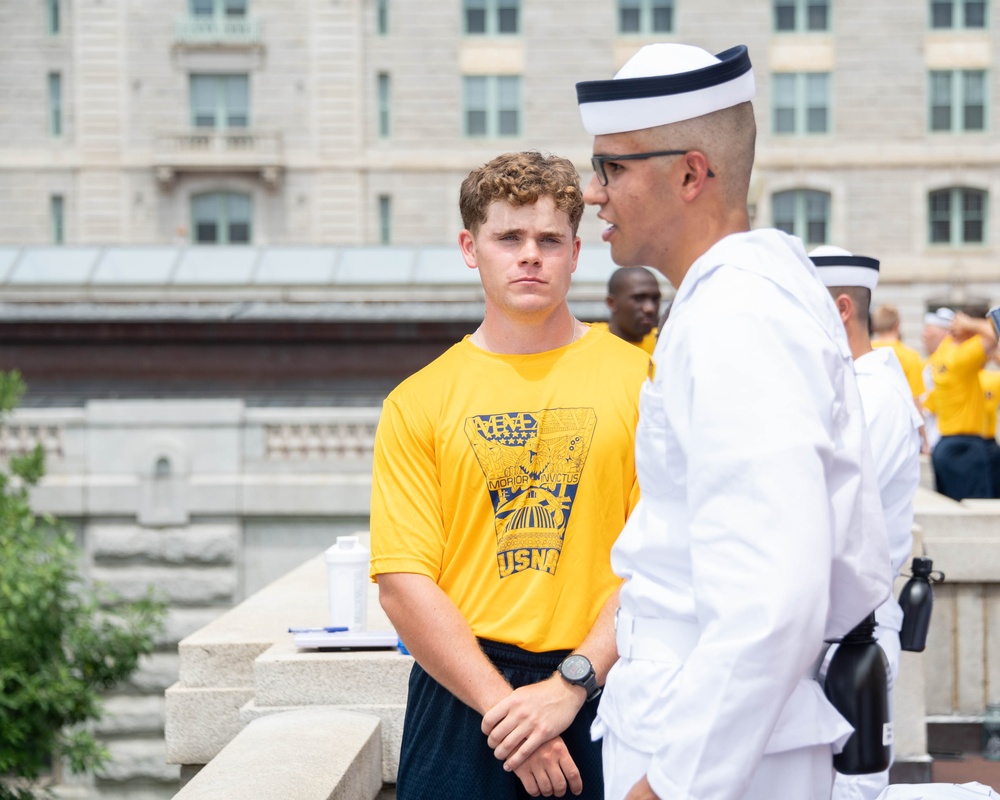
926, 312, 997, 500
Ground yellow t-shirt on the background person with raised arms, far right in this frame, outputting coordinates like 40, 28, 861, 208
926, 336, 986, 436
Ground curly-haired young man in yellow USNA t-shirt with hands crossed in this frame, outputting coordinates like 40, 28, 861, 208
371, 153, 649, 800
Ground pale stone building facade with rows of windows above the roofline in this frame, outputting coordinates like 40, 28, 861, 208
0, 0, 1000, 312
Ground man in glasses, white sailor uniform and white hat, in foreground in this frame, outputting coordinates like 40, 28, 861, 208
564, 44, 889, 800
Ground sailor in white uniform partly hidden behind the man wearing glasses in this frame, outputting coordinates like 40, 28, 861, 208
809, 245, 923, 800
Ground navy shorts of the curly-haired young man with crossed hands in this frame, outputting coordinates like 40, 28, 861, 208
396, 639, 604, 800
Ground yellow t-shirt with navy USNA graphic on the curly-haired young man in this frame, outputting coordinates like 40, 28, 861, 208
371, 330, 649, 652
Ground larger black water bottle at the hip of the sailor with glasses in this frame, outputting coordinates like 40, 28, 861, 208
823, 613, 892, 775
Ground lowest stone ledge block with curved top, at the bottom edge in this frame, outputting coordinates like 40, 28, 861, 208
175, 709, 382, 800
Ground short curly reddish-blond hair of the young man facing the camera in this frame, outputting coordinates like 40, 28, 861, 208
459, 150, 583, 236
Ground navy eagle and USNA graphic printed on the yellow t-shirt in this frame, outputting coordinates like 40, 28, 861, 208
465, 408, 597, 578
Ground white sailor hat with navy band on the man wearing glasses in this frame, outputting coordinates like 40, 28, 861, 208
576, 43, 755, 136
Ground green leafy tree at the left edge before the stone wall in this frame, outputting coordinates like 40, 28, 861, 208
0, 372, 165, 800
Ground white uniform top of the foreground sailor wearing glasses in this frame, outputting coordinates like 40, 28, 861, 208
595, 230, 889, 800
